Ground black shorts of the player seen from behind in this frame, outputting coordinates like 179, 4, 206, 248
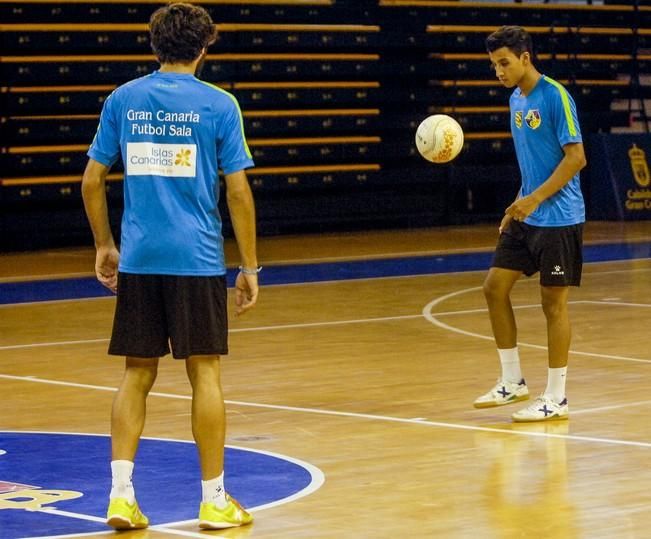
109, 273, 228, 359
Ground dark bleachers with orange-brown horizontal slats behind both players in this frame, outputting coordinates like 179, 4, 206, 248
0, 0, 651, 249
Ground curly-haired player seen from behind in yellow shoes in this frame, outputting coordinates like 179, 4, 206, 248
82, 3, 259, 529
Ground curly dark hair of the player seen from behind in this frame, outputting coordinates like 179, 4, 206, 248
149, 2, 217, 64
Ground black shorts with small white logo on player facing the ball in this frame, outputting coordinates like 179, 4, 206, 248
491, 221, 583, 286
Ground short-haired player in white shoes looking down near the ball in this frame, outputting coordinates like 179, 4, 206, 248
474, 26, 586, 422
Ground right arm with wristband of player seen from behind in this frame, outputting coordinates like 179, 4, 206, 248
226, 170, 258, 315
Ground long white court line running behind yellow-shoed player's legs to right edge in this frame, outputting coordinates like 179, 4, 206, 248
0, 374, 651, 448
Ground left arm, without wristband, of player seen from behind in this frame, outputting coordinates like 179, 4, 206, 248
81, 159, 120, 292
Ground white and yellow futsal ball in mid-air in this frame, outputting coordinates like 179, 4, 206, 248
416, 114, 463, 163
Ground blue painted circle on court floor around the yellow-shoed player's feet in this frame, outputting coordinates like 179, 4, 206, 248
0, 432, 323, 539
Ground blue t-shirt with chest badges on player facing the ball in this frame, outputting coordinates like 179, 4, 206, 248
509, 76, 585, 226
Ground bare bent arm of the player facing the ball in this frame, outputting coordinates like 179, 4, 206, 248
503, 142, 587, 224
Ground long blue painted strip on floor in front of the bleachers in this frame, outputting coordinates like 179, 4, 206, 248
0, 242, 651, 304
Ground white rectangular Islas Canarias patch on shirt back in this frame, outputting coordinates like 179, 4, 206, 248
127, 142, 197, 178
